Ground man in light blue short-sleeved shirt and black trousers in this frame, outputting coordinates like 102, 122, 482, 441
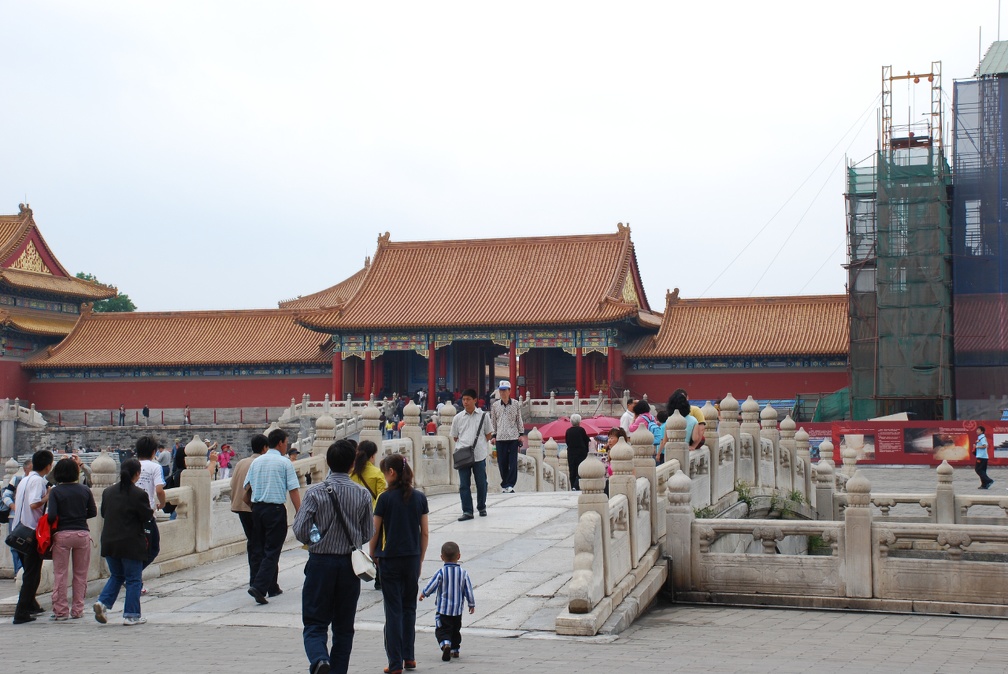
244, 428, 301, 603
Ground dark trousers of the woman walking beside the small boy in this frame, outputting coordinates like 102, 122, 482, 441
380, 556, 421, 672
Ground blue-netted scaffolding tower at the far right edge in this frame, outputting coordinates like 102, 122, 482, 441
953, 42, 1008, 418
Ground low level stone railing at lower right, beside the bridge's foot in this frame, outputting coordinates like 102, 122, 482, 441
662, 463, 1008, 617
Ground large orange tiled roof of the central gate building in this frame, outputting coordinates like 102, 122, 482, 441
294, 223, 656, 332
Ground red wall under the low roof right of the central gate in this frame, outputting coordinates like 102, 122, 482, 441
626, 370, 848, 404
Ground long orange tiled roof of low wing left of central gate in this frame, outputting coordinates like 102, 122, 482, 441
22, 306, 332, 370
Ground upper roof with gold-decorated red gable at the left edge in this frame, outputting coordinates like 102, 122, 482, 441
0, 204, 118, 301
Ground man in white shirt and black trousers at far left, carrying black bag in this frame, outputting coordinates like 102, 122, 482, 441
10, 449, 52, 625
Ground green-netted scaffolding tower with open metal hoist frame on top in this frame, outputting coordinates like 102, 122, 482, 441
846, 61, 953, 419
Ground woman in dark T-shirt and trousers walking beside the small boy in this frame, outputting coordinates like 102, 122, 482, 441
371, 454, 428, 674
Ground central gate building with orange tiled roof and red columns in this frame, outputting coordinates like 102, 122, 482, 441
280, 224, 660, 408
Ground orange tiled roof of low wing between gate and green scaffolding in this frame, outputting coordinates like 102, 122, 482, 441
624, 289, 850, 360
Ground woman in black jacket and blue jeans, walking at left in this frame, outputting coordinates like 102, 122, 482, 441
94, 458, 154, 625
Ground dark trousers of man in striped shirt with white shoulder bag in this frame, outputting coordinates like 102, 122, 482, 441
301, 554, 361, 674
